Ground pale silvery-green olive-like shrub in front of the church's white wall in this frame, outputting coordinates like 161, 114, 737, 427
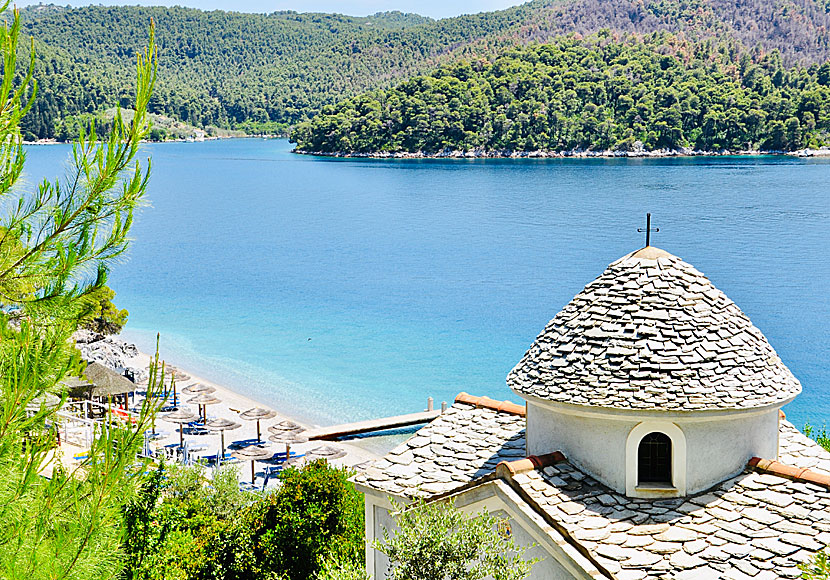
375, 500, 533, 580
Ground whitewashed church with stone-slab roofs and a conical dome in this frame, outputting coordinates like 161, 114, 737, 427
355, 245, 830, 580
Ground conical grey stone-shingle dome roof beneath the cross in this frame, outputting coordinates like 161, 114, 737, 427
507, 246, 801, 411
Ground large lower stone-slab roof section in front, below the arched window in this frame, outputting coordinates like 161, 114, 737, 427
513, 438, 830, 580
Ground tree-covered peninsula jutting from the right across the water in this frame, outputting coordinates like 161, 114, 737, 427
292, 31, 830, 155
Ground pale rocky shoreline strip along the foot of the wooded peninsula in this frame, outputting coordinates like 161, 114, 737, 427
292, 148, 830, 159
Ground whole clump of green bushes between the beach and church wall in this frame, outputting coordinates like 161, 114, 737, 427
122, 461, 363, 580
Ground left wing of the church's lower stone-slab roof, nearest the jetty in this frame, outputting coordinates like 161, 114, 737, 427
354, 403, 525, 497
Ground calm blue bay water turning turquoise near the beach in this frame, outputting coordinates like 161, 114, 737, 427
21, 140, 830, 426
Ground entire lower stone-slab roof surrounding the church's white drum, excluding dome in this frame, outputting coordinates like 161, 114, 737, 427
355, 403, 830, 580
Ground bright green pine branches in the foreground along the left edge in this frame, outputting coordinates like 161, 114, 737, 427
0, 9, 160, 580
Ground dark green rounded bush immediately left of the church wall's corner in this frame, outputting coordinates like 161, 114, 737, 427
249, 460, 364, 580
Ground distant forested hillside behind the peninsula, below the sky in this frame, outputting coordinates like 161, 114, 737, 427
14, 0, 830, 138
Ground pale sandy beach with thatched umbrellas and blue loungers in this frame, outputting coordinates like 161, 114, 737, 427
121, 351, 378, 487
